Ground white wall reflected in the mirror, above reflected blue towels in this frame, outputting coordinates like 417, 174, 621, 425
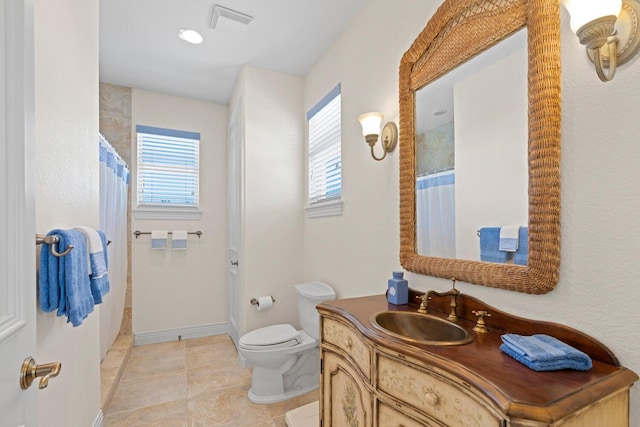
453, 47, 529, 260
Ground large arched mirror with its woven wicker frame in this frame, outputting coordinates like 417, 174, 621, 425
399, 0, 562, 294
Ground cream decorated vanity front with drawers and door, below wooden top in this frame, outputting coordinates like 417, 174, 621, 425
321, 315, 506, 427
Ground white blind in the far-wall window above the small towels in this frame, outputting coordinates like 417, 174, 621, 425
136, 125, 200, 208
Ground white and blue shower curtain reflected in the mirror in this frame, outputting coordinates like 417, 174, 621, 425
416, 169, 456, 258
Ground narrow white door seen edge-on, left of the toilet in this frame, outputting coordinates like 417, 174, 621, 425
227, 101, 243, 346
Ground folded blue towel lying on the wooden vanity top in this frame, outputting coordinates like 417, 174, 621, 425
500, 334, 592, 371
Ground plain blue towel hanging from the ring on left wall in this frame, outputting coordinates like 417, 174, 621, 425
38, 229, 94, 326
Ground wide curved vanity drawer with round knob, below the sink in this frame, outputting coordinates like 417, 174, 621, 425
377, 353, 503, 427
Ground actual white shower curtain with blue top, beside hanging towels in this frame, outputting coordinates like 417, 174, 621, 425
99, 135, 129, 360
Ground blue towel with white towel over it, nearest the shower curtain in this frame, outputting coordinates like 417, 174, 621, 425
75, 226, 110, 304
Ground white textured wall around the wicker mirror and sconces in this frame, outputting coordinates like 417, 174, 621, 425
305, 0, 640, 425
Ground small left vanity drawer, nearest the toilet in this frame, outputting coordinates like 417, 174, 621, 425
322, 317, 371, 380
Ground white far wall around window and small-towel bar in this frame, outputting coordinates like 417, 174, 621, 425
131, 89, 229, 339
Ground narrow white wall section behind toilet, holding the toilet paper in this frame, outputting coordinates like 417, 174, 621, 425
231, 66, 305, 334
